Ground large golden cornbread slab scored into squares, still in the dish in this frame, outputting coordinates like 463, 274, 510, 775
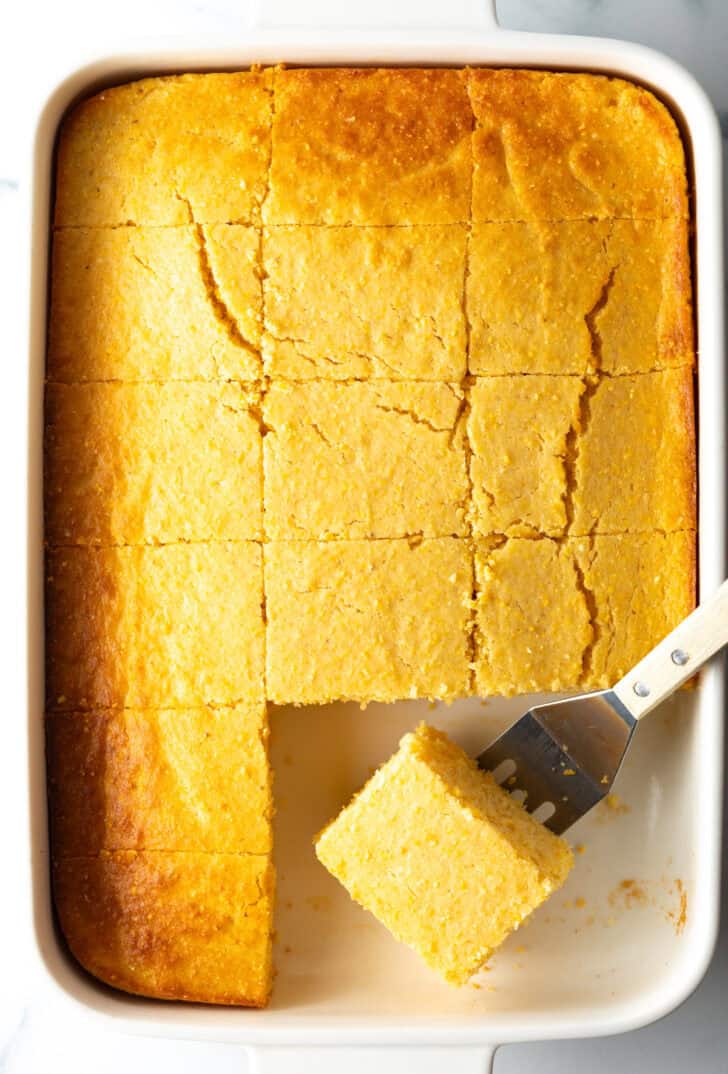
45, 69, 696, 1005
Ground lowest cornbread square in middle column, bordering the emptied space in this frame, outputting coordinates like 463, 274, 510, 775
264, 537, 472, 705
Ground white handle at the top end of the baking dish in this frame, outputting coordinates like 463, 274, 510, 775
250, 0, 498, 32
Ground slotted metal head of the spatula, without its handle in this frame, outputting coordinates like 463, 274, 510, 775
478, 690, 637, 834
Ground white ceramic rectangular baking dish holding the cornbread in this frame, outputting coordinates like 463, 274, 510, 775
22, 0, 726, 1072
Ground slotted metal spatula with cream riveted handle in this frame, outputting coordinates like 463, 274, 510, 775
478, 581, 728, 834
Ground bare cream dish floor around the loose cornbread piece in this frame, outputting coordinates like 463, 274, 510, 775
271, 692, 698, 1020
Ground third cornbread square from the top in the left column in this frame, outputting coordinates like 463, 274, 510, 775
45, 381, 263, 545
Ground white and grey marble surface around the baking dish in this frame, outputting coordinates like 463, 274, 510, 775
0, 0, 728, 1074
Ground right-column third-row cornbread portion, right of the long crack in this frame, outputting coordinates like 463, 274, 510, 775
571, 367, 696, 535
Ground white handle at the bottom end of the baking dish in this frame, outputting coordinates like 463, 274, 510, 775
249, 1045, 495, 1074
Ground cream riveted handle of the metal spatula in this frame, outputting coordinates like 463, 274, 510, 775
613, 580, 728, 720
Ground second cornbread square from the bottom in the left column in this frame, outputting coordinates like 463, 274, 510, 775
46, 701, 273, 857
